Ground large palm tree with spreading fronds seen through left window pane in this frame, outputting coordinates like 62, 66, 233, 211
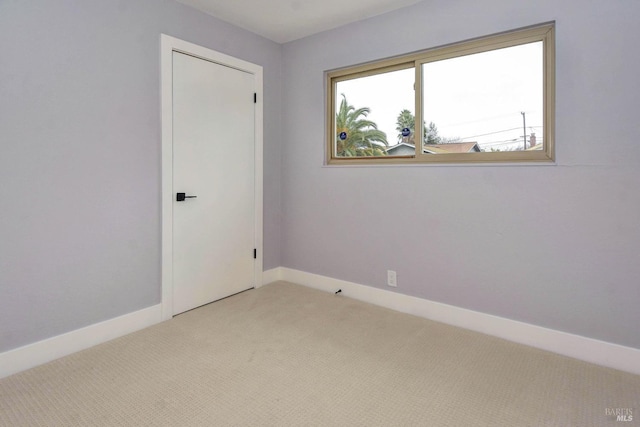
336, 94, 388, 157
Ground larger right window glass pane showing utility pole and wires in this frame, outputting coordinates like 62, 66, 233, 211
422, 42, 544, 154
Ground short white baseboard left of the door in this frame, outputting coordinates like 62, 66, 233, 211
0, 304, 162, 378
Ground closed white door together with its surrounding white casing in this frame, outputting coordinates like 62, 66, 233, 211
161, 35, 262, 320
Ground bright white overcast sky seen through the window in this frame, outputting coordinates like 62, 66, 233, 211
336, 42, 543, 151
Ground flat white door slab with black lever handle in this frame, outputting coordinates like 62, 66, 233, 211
172, 52, 256, 315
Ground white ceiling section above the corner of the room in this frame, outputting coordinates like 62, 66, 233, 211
178, 0, 422, 43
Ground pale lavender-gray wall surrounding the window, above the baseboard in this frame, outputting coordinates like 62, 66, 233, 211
282, 0, 640, 348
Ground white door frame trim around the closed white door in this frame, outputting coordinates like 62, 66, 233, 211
160, 34, 263, 320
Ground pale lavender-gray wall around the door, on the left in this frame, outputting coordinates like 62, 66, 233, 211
0, 0, 282, 352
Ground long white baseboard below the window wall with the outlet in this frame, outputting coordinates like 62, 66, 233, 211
276, 267, 640, 374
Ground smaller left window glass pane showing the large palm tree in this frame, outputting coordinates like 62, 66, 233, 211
333, 68, 415, 157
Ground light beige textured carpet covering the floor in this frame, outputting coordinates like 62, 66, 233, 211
0, 282, 640, 427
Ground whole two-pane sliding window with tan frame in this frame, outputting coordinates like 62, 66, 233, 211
326, 23, 555, 164
